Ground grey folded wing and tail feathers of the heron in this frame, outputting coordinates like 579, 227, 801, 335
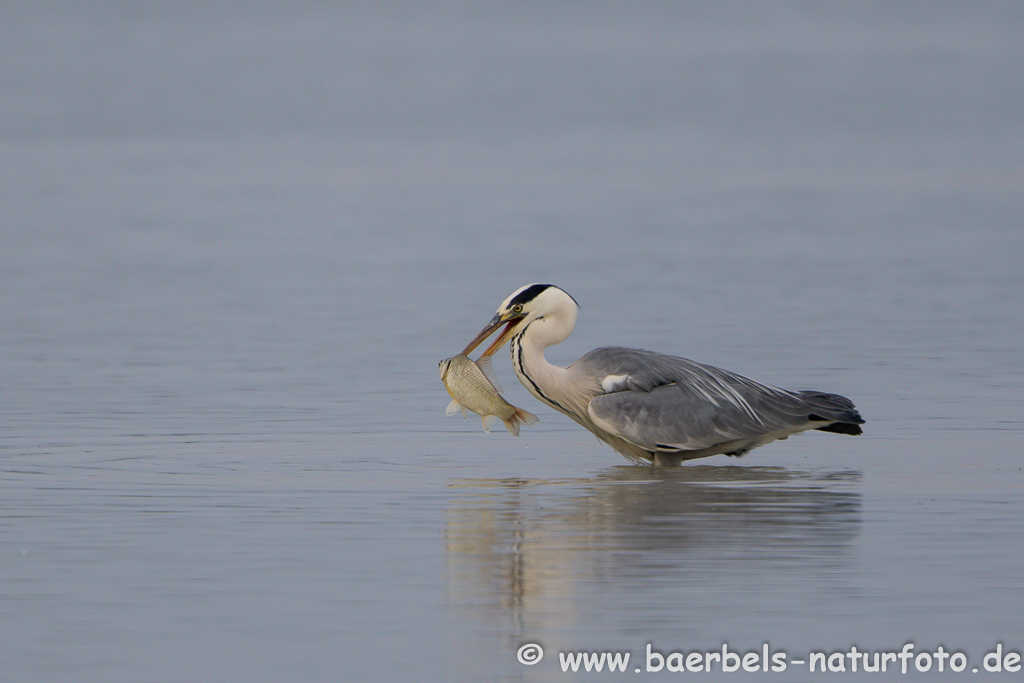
578, 347, 862, 451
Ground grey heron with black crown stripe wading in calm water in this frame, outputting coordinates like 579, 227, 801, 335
463, 284, 864, 465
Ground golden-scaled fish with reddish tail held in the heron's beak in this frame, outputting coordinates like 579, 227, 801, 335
438, 353, 537, 436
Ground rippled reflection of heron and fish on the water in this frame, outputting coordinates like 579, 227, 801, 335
445, 466, 861, 638
